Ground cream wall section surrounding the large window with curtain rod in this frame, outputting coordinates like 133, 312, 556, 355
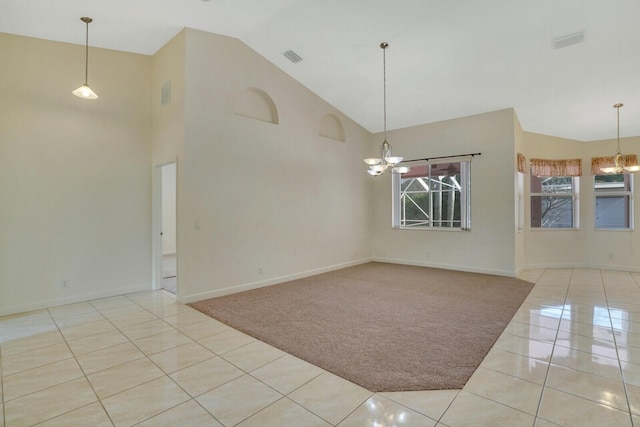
368, 109, 516, 276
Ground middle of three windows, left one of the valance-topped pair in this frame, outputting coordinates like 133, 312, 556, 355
531, 174, 578, 228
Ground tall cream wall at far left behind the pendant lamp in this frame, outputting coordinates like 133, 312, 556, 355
0, 34, 151, 315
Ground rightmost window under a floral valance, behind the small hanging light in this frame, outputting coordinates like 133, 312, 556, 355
593, 174, 633, 229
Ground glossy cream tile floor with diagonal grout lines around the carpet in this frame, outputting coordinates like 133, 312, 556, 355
0, 269, 640, 427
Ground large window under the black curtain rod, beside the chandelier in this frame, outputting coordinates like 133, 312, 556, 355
392, 161, 471, 230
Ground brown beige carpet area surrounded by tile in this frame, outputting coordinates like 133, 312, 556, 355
191, 263, 533, 392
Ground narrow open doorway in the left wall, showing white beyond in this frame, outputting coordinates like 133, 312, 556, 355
160, 163, 178, 295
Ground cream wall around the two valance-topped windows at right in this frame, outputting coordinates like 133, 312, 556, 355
525, 133, 640, 271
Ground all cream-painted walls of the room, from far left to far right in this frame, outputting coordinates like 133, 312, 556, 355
0, 30, 640, 315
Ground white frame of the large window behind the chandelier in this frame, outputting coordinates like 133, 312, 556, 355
391, 157, 471, 231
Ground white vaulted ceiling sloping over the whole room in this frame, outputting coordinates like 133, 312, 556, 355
0, 0, 640, 141
